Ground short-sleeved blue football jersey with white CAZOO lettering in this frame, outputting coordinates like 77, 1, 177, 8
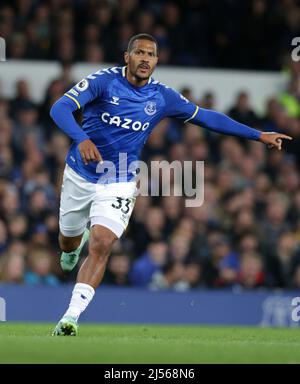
63, 67, 198, 183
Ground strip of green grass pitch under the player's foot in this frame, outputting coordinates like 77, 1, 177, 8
0, 323, 300, 364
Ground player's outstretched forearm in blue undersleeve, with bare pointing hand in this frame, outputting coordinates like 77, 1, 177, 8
190, 107, 292, 150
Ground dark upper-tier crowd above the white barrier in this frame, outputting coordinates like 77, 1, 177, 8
0, 0, 300, 69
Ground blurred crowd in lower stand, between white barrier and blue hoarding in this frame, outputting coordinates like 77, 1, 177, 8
0, 54, 300, 290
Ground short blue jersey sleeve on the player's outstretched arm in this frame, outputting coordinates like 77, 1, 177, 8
163, 87, 199, 123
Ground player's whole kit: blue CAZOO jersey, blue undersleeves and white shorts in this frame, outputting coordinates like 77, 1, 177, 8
50, 67, 260, 237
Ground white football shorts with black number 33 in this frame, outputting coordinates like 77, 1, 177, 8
59, 164, 137, 237
